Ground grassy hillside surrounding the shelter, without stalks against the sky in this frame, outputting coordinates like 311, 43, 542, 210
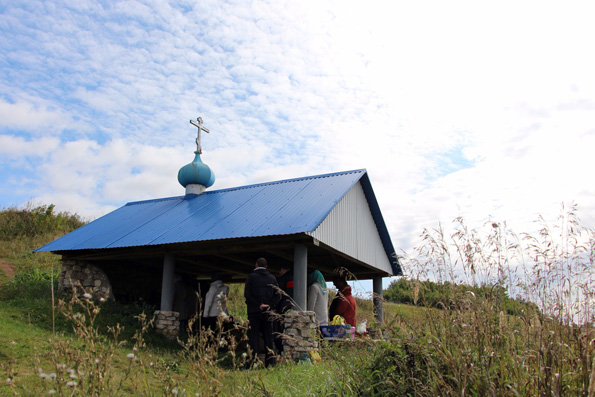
0, 206, 595, 396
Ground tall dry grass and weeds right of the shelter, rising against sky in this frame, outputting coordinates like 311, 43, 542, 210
358, 206, 595, 396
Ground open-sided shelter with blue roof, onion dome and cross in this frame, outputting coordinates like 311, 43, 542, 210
38, 119, 401, 332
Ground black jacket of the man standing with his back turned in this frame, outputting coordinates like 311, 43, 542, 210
244, 267, 281, 313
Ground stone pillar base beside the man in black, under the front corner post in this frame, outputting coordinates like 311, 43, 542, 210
283, 311, 318, 360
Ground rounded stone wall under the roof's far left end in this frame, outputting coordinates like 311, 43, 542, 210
58, 260, 114, 300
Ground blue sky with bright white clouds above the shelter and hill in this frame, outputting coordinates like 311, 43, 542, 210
0, 0, 595, 284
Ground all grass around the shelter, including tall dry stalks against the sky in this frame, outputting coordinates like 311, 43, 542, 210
0, 203, 595, 396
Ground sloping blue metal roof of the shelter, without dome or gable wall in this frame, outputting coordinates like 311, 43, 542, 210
36, 169, 394, 274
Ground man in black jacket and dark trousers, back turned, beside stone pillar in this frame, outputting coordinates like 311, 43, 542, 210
244, 258, 281, 367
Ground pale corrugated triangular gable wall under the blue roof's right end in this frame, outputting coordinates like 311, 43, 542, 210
309, 182, 393, 274
